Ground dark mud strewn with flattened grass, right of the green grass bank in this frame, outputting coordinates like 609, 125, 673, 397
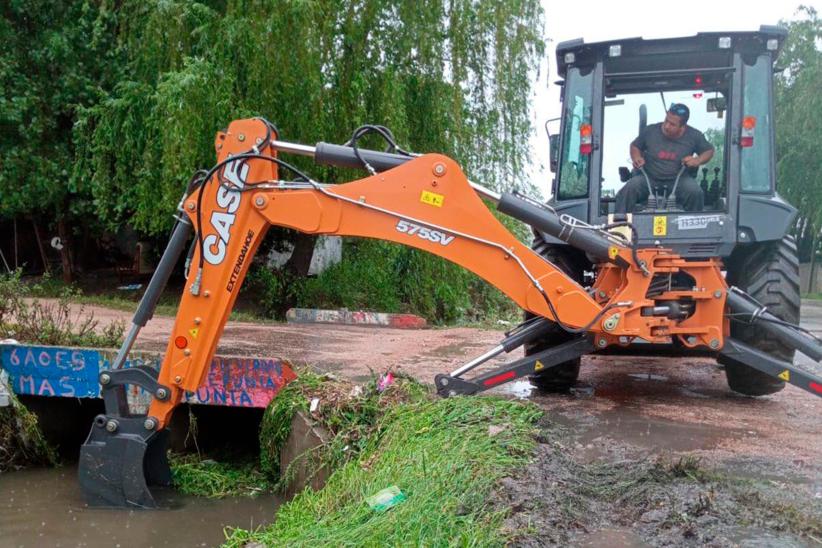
493, 419, 822, 547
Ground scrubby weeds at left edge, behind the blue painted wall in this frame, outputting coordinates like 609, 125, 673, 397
0, 271, 125, 348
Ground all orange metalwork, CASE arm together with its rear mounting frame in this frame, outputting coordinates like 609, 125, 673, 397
149, 119, 727, 427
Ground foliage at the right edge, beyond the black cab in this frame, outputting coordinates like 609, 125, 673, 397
775, 7, 822, 248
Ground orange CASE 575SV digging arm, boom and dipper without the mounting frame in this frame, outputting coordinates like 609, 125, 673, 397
149, 119, 603, 427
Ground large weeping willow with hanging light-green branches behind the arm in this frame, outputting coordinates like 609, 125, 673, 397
74, 0, 543, 317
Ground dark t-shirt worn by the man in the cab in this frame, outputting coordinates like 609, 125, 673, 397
631, 123, 713, 181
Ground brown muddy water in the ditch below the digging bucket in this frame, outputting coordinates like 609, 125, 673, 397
0, 467, 280, 548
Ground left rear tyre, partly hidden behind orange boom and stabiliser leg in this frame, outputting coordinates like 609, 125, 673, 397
525, 238, 590, 392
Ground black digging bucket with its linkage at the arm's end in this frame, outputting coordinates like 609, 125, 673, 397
79, 366, 171, 508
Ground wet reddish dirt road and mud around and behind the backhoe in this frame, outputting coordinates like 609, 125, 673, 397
17, 302, 822, 546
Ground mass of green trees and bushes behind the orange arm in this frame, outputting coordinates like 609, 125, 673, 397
0, 0, 544, 322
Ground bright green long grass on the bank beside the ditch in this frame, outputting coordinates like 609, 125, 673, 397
226, 393, 541, 547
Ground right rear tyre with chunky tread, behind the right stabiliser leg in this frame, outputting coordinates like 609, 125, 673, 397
718, 236, 801, 396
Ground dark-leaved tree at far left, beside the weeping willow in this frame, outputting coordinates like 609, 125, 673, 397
0, 0, 119, 279
